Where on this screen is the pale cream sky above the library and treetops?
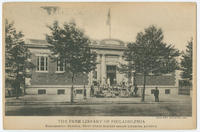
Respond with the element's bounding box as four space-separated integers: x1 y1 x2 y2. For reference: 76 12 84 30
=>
3 3 196 50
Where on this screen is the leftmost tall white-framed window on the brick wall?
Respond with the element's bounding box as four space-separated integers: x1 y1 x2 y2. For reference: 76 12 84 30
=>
37 56 48 71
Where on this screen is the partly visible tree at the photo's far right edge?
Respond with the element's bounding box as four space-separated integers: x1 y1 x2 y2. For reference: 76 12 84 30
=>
181 39 193 81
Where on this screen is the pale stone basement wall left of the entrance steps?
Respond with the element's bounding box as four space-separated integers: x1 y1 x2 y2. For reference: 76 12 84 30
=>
26 85 90 102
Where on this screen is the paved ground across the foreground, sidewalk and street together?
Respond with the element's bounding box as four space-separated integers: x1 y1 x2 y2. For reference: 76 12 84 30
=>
5 95 192 116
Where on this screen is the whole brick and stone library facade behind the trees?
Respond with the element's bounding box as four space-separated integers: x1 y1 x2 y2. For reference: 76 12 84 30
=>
23 39 179 101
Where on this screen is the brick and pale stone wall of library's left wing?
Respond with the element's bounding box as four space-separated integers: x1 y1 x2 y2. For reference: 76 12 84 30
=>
26 48 90 102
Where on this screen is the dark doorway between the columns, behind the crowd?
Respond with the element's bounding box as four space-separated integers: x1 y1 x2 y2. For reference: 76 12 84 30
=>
106 65 116 86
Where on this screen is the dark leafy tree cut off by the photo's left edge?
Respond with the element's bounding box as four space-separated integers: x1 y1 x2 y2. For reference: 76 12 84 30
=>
5 19 34 98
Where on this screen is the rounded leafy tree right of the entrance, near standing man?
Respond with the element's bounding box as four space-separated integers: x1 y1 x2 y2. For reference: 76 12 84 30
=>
122 26 179 101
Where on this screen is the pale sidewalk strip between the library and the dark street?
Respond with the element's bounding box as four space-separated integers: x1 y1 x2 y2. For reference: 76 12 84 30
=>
6 95 192 105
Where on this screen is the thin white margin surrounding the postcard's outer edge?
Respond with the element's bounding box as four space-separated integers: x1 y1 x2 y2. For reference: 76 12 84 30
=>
0 0 200 132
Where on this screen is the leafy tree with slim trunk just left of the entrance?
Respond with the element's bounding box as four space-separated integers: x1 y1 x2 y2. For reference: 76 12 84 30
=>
46 21 96 103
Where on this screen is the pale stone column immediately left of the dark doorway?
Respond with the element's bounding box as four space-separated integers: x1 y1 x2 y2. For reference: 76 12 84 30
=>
101 55 106 84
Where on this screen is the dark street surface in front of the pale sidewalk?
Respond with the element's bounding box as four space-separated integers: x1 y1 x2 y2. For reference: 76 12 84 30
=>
6 103 192 116
